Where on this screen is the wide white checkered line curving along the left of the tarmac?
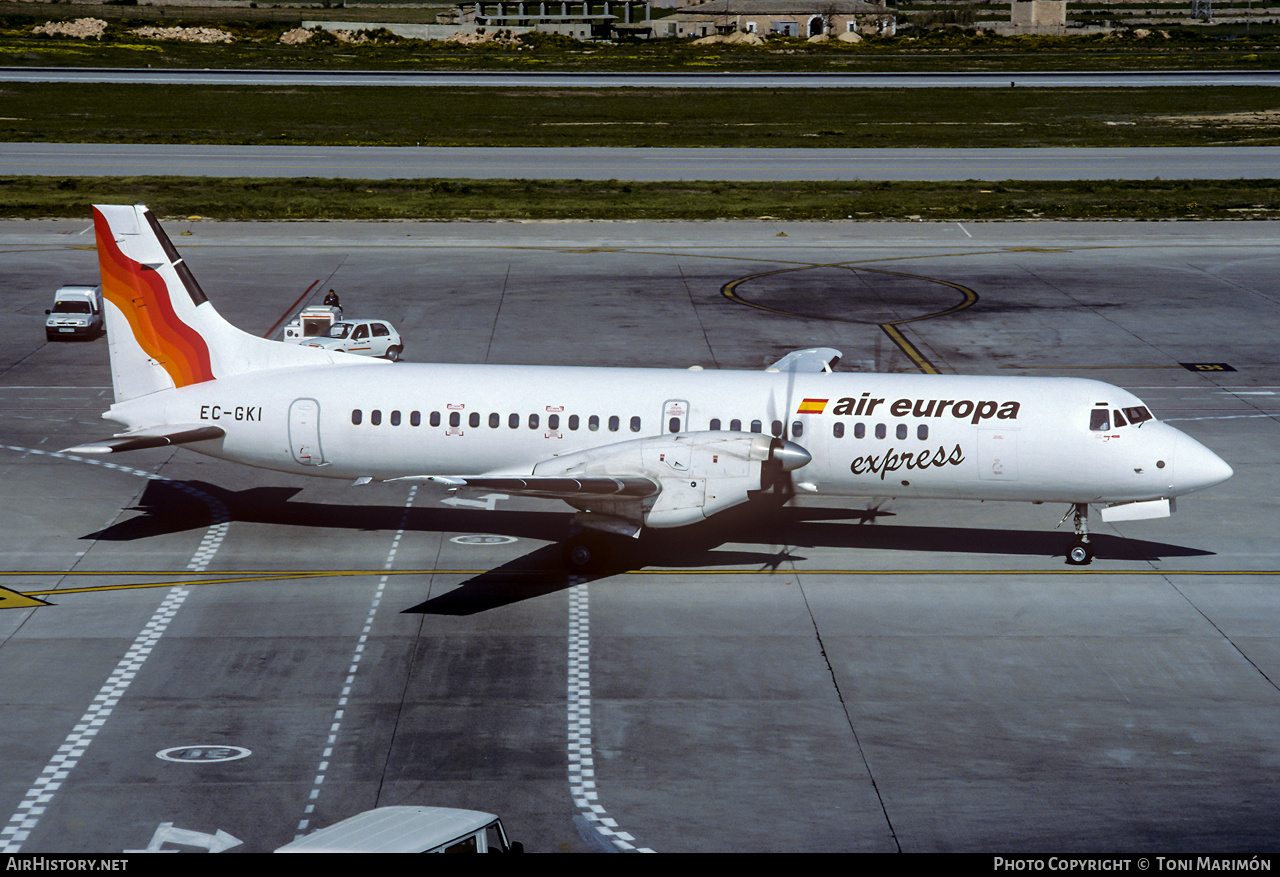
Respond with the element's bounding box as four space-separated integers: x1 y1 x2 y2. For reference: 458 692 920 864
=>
0 444 230 854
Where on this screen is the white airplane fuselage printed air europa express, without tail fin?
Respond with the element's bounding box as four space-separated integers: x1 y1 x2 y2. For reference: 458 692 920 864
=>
105 364 1230 503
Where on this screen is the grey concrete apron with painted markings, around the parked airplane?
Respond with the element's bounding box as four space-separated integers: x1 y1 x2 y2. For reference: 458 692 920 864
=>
0 218 1280 857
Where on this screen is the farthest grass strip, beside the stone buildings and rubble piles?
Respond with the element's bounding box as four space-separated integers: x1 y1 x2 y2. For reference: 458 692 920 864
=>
0 15 1280 72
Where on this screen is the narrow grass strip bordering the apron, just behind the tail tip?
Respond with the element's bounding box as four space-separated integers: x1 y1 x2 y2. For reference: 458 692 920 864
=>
0 177 1280 221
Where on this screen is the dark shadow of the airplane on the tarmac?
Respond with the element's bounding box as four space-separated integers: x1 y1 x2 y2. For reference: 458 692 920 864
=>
83 481 1212 615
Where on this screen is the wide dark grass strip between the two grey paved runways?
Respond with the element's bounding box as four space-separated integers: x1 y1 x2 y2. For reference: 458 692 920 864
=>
0 83 1280 147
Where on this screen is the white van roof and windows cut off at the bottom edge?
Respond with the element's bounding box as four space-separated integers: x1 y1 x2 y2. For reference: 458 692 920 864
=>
275 807 509 853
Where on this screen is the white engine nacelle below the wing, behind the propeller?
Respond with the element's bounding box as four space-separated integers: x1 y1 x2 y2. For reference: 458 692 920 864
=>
534 431 812 527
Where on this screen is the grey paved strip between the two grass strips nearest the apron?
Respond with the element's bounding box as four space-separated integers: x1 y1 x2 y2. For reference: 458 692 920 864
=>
0 143 1280 182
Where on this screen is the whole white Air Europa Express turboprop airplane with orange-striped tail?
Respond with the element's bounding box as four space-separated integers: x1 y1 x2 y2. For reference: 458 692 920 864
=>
69 205 1231 570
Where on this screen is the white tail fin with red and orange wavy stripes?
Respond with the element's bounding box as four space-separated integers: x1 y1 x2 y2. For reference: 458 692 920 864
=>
93 204 380 402
